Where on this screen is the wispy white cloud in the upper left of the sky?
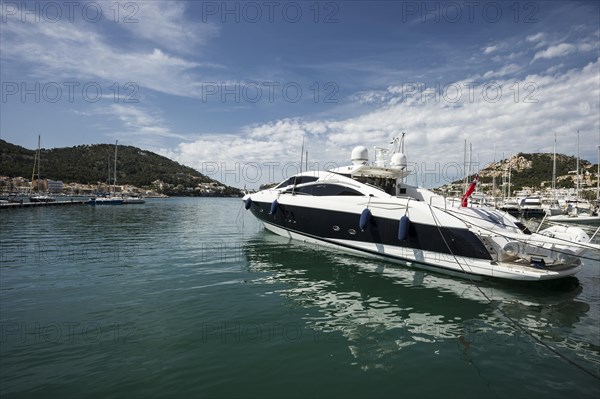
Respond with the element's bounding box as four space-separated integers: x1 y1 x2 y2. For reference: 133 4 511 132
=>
0 2 215 97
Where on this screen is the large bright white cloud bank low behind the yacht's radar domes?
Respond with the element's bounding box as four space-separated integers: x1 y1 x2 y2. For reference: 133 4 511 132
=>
163 61 600 187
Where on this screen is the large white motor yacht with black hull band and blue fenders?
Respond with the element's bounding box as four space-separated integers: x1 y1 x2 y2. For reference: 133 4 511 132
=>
243 137 600 281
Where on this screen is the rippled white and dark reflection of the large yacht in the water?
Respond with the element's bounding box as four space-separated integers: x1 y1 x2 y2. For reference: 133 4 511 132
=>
243 233 600 368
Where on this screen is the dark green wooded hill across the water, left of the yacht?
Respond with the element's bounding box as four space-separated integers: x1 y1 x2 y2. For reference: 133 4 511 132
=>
0 140 241 196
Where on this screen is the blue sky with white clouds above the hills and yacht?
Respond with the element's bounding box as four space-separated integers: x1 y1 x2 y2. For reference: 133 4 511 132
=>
0 1 600 187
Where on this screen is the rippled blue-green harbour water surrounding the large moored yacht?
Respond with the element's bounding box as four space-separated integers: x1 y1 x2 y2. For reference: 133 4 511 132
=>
0 198 600 399
